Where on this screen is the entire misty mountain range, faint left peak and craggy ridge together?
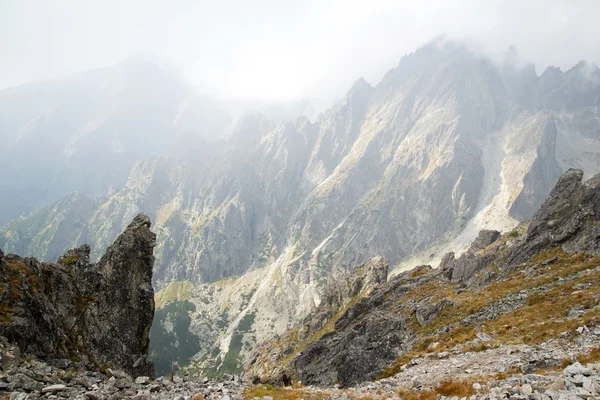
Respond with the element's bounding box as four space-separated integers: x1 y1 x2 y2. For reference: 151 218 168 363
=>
0 40 600 376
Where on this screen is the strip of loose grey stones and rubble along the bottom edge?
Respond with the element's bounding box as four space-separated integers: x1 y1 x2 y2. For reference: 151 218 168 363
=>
0 328 600 400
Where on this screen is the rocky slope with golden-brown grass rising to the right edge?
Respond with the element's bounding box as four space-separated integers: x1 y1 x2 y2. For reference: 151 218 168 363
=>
248 169 600 387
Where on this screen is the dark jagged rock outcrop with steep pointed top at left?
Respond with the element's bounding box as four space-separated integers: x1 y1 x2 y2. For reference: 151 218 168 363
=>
0 214 156 376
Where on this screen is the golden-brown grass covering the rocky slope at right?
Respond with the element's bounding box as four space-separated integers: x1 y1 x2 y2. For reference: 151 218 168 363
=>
379 248 600 379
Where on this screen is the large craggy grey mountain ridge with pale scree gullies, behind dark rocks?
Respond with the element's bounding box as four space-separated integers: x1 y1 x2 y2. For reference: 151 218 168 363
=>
0 41 600 373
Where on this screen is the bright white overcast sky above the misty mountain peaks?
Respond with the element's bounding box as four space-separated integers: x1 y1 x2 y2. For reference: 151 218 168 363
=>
0 0 600 100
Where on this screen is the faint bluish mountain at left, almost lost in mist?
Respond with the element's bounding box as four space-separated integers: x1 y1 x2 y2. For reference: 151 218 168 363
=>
0 57 231 224
